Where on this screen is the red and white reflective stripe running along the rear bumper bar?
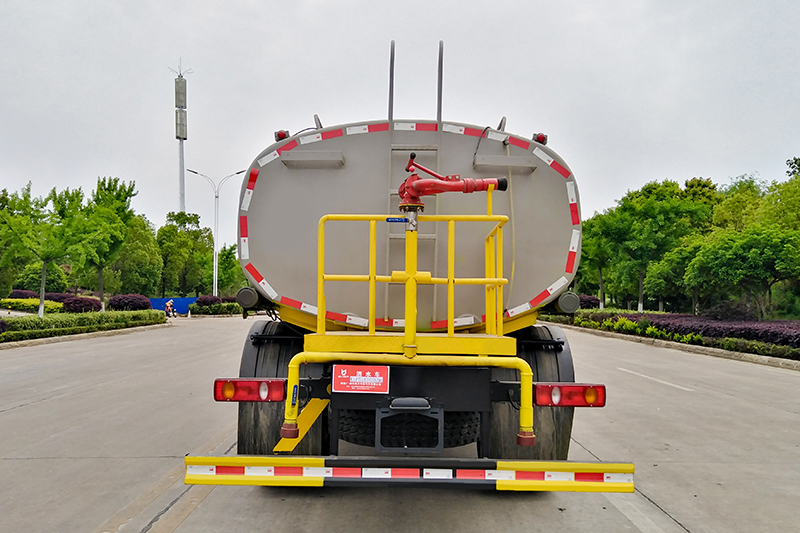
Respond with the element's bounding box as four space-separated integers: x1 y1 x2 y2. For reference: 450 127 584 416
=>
186 465 633 483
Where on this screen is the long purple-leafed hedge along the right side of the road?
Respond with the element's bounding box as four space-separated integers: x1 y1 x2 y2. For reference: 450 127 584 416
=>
620 314 800 348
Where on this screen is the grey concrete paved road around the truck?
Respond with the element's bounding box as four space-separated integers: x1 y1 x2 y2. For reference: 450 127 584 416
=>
0 318 800 533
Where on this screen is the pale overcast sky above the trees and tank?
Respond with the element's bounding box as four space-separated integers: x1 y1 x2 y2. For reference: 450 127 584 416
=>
0 0 800 247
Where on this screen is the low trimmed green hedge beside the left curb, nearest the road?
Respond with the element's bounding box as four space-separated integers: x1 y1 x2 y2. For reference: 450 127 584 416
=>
0 309 166 342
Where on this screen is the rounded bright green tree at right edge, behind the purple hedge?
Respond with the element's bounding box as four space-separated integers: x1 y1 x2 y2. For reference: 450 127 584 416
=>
684 226 800 319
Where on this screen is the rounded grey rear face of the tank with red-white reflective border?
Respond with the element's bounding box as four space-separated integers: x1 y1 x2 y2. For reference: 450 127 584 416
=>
239 119 581 331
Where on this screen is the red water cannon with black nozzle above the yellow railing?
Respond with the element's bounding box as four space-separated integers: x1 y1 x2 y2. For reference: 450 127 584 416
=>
398 152 508 211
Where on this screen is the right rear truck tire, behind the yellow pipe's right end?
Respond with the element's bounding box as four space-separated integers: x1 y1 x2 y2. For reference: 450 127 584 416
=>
488 325 575 461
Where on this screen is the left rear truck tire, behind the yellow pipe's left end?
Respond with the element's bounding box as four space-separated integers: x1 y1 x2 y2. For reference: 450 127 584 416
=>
237 320 327 455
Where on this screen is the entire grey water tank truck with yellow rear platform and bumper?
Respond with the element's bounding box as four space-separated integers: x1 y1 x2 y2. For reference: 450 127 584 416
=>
185 43 634 492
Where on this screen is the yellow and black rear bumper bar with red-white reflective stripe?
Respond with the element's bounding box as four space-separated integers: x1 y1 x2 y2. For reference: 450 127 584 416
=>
184 456 634 492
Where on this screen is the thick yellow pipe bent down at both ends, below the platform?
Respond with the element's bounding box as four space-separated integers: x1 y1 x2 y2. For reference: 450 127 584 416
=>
284 354 533 437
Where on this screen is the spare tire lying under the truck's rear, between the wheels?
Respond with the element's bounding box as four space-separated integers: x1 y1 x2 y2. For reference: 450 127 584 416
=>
339 409 481 448
